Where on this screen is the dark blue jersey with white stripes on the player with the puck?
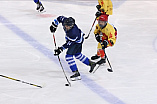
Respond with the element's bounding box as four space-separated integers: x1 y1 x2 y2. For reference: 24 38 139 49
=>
54 16 84 49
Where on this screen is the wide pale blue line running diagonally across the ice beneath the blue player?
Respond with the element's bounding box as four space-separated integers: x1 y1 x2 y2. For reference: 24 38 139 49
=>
0 15 125 104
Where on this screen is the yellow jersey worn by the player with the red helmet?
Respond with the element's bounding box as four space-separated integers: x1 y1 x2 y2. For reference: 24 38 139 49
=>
94 23 117 46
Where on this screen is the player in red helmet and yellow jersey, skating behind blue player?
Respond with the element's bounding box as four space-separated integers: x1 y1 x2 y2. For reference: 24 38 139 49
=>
91 15 117 65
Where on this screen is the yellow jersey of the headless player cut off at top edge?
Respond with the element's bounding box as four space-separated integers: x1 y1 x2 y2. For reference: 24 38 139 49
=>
98 0 113 15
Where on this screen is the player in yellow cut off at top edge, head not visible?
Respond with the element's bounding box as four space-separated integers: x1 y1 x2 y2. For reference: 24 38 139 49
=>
95 0 113 19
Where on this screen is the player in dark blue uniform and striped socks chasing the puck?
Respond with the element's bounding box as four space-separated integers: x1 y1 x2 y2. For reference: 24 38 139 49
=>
50 16 96 81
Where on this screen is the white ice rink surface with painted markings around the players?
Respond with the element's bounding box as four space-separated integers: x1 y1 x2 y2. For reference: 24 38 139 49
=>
0 0 157 104
